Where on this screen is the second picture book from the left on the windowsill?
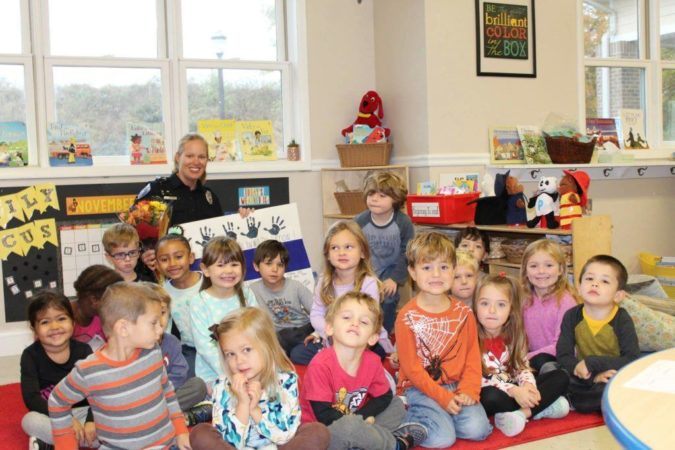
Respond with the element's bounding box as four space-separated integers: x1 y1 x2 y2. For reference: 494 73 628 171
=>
47 122 93 166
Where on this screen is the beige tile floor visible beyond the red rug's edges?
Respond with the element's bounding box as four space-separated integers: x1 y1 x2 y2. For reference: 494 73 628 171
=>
0 356 621 450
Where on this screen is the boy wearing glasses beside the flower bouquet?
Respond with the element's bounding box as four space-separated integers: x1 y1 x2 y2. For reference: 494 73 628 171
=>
102 223 155 282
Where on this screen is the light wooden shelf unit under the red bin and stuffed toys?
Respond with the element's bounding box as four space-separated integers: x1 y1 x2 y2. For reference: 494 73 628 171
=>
420 215 612 284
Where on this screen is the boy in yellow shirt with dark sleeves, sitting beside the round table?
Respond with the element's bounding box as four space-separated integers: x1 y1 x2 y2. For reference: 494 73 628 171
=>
557 255 640 412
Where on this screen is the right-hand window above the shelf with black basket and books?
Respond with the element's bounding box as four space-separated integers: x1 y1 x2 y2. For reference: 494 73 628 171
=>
582 0 675 148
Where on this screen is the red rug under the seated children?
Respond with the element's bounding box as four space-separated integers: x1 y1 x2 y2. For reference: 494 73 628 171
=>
0 383 604 450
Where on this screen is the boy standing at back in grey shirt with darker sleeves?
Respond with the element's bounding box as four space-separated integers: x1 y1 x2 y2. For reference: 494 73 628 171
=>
354 172 415 333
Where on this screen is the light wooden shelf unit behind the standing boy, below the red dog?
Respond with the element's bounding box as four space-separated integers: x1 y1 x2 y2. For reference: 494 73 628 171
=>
321 166 410 231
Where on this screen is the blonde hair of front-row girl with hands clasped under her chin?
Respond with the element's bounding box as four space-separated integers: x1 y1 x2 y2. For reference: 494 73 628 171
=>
213 306 295 397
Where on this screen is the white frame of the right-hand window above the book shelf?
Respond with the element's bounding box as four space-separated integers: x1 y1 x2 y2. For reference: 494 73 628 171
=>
577 0 675 153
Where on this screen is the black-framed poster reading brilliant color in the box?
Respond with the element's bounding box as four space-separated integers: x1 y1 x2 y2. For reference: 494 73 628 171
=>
476 0 537 78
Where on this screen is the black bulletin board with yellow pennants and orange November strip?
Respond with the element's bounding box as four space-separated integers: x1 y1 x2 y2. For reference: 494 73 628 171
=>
0 177 289 322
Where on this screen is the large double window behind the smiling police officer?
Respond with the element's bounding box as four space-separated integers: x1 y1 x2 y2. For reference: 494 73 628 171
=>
0 0 309 178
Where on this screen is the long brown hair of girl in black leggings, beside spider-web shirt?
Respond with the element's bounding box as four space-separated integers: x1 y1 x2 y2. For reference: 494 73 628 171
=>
473 274 530 376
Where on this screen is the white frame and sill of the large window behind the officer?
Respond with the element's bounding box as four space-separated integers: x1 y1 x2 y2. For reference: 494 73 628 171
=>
0 0 311 180
